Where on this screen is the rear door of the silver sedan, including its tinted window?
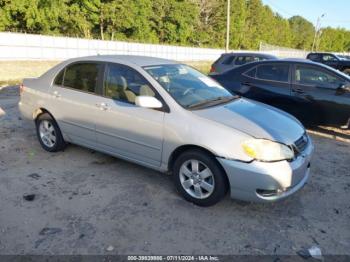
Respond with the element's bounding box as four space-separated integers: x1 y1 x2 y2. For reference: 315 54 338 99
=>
49 62 103 147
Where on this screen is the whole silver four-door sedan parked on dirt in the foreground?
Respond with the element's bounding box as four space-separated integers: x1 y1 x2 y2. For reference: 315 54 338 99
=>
19 55 313 206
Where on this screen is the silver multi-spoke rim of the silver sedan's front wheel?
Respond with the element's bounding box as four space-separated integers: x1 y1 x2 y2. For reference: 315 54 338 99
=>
179 159 215 199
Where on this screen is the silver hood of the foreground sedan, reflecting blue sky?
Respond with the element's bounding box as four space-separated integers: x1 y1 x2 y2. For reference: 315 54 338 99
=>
192 98 305 145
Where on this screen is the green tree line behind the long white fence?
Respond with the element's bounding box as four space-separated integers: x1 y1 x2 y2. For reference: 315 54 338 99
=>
0 0 350 52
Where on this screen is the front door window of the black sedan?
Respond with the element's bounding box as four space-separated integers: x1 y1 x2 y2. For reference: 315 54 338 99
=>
295 66 345 88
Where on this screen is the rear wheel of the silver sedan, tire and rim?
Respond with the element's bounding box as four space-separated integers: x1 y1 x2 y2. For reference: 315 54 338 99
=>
35 113 66 152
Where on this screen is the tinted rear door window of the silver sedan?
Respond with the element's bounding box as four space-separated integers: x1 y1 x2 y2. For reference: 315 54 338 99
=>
63 63 101 93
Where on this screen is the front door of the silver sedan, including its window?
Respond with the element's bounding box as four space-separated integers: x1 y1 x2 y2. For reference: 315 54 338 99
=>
96 63 165 167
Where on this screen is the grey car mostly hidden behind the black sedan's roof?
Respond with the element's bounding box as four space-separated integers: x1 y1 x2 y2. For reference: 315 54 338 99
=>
209 53 277 75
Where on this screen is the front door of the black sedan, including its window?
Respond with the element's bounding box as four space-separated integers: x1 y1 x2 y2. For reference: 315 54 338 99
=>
292 64 350 125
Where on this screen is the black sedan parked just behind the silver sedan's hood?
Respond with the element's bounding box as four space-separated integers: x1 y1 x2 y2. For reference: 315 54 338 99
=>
212 59 350 128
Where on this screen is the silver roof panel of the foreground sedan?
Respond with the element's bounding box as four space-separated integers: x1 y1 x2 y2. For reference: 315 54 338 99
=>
62 55 179 67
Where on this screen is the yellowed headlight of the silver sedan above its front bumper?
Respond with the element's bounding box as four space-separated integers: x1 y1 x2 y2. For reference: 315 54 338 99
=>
242 139 294 162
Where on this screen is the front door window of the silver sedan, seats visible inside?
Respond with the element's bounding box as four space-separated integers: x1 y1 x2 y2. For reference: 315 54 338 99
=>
104 64 156 104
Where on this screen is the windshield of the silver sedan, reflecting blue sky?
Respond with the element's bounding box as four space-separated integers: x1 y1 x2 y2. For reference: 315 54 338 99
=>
144 64 236 109
